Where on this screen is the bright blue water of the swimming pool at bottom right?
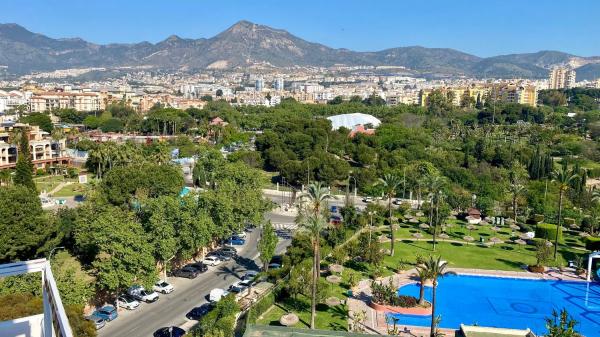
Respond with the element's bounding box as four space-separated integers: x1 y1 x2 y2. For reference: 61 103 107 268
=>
388 275 600 337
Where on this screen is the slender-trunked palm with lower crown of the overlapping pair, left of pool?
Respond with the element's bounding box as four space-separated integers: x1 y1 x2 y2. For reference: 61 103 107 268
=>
300 213 327 329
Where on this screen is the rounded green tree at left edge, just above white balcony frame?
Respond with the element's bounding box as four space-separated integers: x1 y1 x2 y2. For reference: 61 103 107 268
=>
0 185 49 262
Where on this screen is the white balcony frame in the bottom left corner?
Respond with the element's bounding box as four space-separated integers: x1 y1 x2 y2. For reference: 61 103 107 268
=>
0 259 73 337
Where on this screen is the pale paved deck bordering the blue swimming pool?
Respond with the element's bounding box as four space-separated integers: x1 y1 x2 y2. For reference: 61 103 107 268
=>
347 268 586 337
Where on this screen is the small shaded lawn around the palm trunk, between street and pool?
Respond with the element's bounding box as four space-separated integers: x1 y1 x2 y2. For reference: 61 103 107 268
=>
256 276 349 331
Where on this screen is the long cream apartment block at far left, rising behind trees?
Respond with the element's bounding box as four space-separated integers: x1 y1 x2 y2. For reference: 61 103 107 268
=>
29 91 104 112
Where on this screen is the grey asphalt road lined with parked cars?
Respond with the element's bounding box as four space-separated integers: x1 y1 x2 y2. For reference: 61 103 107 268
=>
98 214 294 337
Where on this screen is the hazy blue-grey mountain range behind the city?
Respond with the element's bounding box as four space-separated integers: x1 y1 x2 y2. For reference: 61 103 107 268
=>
0 21 600 80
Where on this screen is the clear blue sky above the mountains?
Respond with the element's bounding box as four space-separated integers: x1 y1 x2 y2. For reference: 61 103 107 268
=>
0 0 600 56
